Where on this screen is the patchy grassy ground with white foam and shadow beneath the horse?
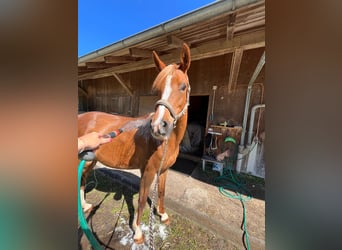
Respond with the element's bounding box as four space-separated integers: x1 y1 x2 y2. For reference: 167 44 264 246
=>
78 168 232 250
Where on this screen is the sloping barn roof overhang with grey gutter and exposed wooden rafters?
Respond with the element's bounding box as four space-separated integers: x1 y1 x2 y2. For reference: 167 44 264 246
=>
78 0 265 80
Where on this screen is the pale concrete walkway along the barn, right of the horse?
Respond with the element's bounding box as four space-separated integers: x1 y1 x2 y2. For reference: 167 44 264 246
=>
79 159 265 249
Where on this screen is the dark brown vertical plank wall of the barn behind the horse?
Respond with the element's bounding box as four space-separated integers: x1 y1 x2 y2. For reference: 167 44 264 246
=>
79 48 265 134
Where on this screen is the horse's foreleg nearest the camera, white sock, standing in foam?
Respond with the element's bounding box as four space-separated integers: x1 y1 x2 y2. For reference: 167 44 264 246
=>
133 171 155 244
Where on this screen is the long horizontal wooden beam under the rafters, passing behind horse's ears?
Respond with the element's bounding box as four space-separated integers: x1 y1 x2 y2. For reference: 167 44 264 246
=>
78 30 265 80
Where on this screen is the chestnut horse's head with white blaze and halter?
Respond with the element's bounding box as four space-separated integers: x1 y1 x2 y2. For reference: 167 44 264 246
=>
151 44 191 140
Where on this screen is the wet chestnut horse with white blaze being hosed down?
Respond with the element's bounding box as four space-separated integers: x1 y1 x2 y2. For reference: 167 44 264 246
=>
78 44 191 244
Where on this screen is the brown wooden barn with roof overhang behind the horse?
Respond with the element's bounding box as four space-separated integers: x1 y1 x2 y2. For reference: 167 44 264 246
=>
78 0 265 178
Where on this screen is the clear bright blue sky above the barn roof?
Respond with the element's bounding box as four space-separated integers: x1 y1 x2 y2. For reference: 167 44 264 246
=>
78 0 215 56
